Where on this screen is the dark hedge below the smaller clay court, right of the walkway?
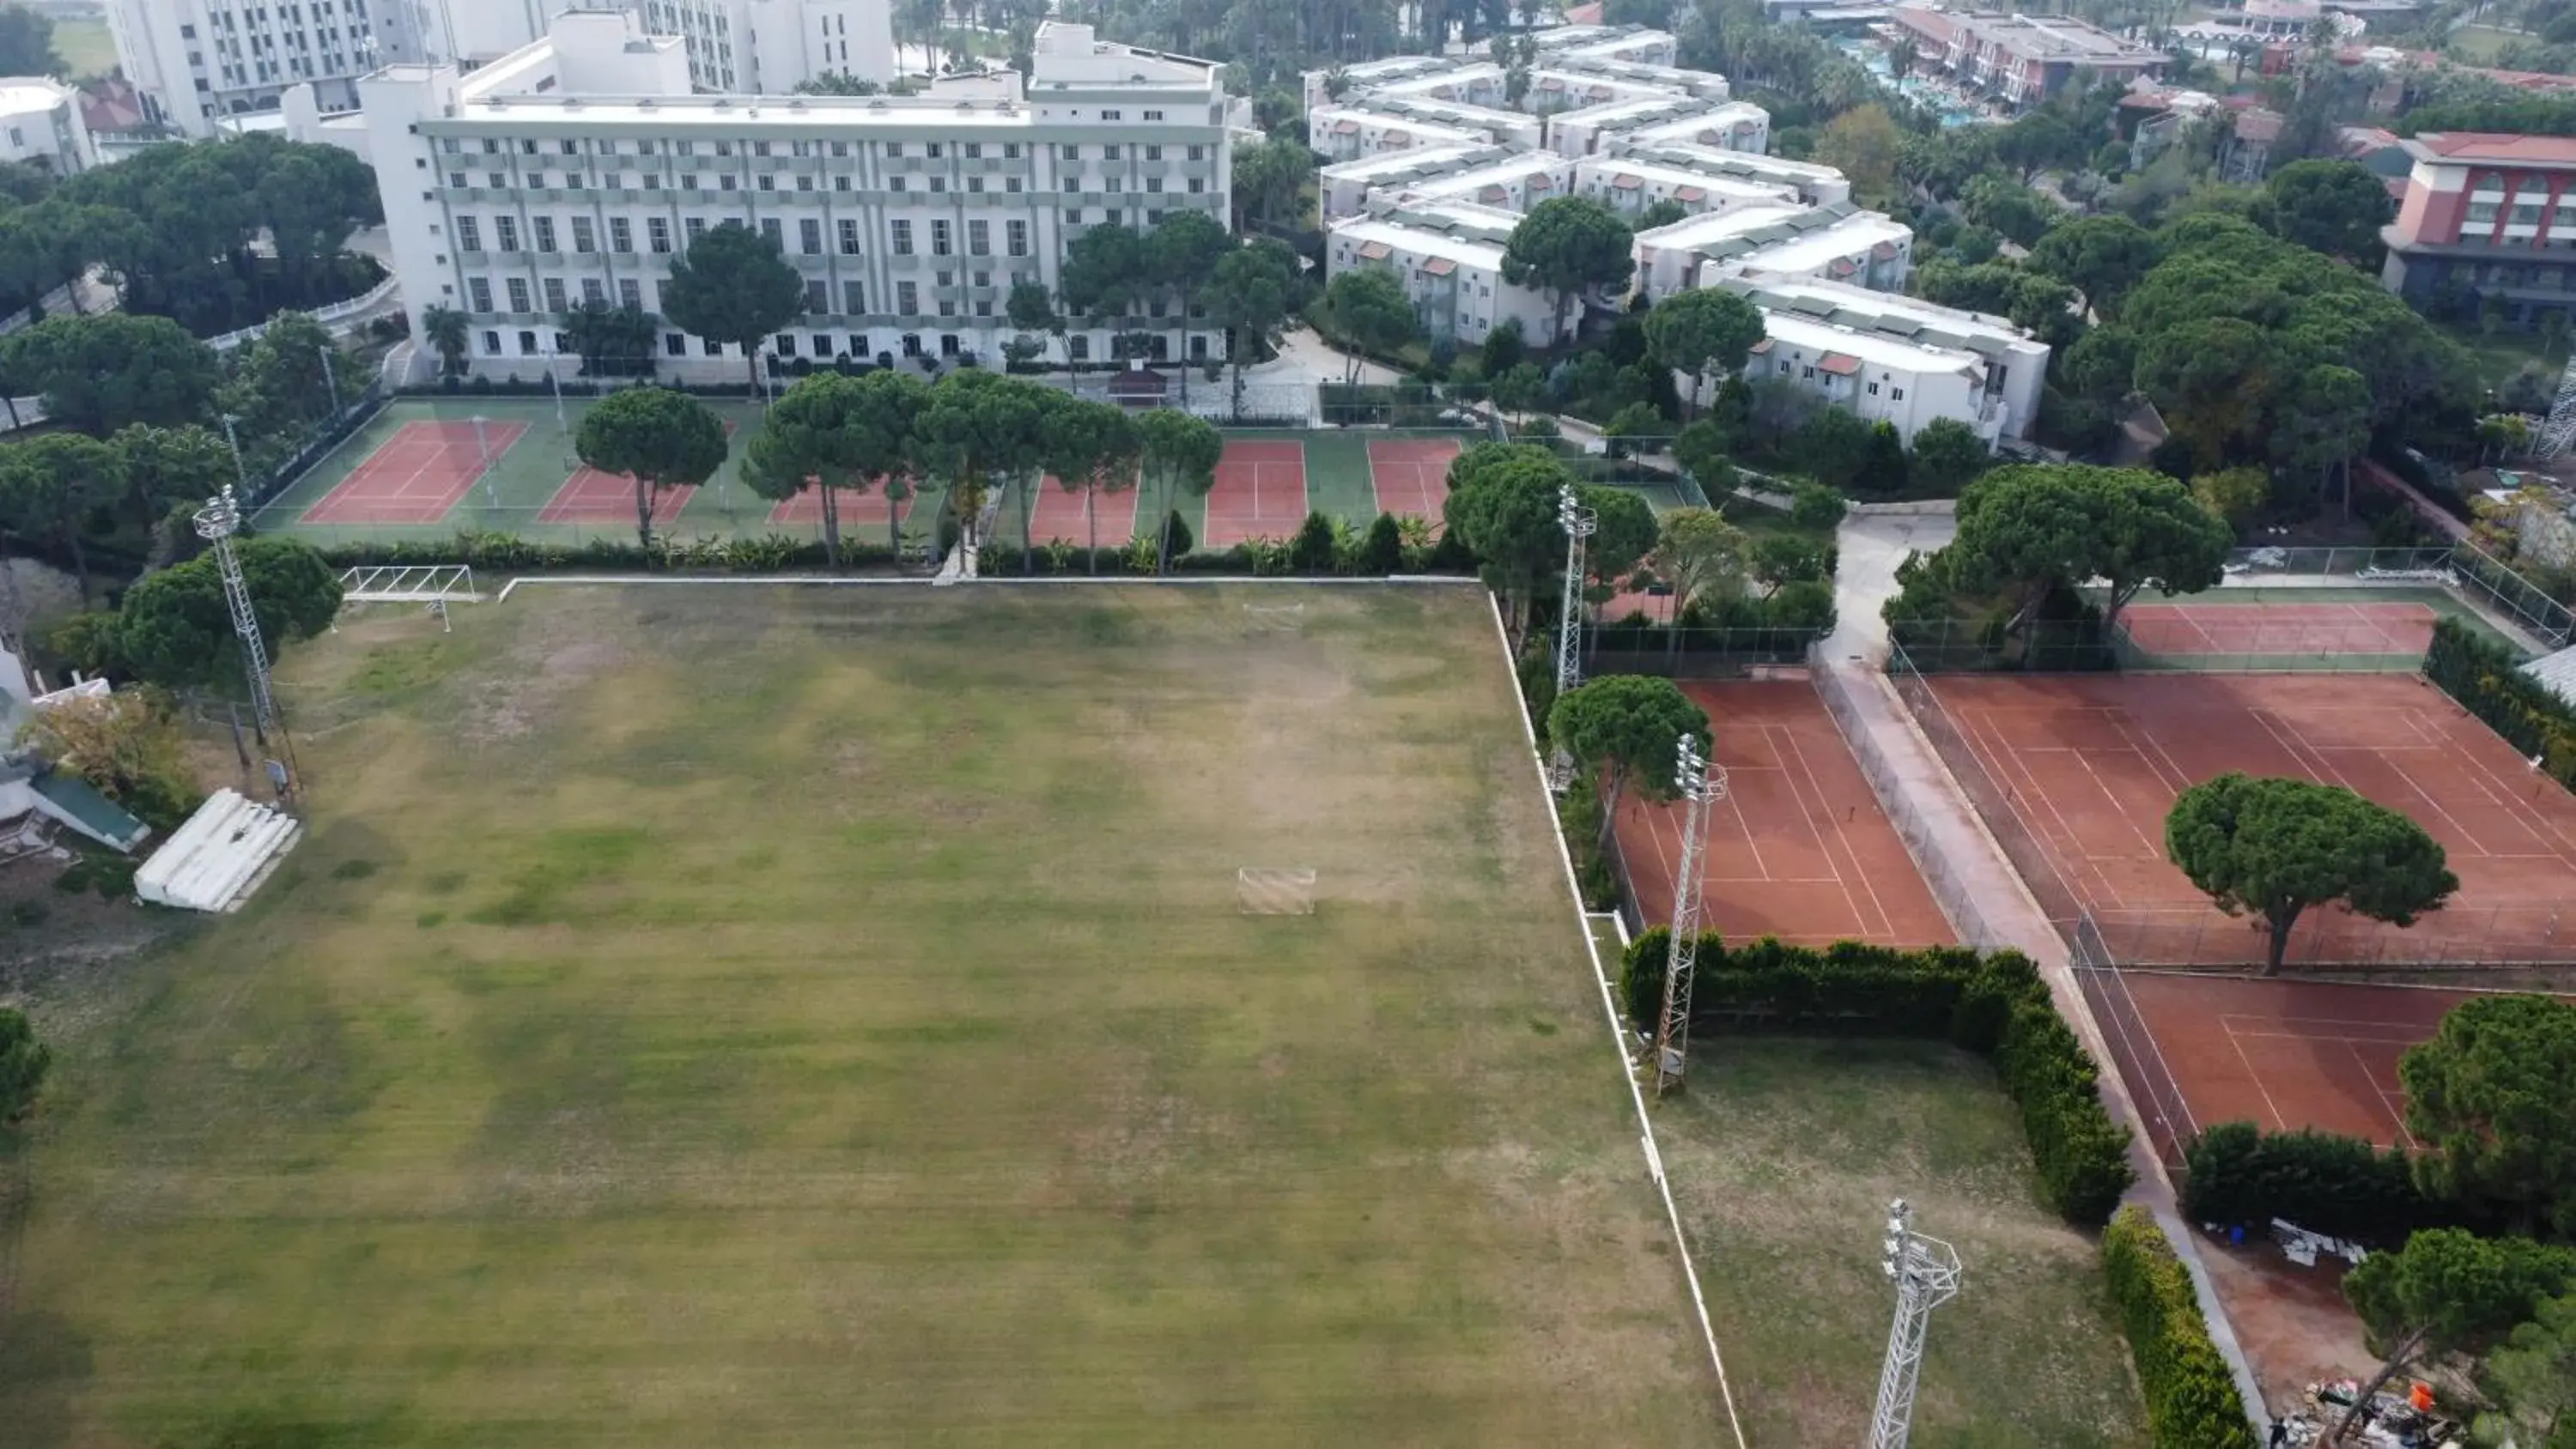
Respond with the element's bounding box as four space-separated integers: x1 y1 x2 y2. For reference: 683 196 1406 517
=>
2182 1122 2445 1248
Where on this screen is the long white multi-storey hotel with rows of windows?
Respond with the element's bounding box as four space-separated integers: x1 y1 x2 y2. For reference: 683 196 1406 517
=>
361 13 1231 381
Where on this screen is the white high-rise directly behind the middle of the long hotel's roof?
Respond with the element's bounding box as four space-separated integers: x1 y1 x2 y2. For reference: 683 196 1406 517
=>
623 0 894 95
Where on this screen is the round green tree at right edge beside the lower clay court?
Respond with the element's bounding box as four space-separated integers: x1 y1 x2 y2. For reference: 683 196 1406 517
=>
2398 996 2576 1238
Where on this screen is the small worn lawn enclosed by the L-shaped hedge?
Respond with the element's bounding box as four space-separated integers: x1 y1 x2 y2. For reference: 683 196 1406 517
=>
1656 1034 2146 1449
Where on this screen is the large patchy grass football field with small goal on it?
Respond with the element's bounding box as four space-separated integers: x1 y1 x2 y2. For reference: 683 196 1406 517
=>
15 587 1731 1449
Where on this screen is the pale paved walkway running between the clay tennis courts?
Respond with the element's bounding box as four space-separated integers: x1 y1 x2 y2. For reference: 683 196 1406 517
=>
1819 515 2269 1434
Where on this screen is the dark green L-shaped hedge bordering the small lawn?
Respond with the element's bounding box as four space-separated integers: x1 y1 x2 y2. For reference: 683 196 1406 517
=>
1620 926 2136 1228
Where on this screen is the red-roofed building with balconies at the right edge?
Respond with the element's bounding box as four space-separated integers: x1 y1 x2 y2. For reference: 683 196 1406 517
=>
2380 131 2576 327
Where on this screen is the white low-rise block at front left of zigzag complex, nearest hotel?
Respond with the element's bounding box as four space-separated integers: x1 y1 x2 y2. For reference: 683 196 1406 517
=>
1324 203 1582 348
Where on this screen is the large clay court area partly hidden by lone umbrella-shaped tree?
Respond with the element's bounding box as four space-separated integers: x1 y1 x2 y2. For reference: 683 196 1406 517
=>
1906 675 2576 967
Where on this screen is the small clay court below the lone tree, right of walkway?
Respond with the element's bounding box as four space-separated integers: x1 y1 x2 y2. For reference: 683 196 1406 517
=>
2076 970 2514 1161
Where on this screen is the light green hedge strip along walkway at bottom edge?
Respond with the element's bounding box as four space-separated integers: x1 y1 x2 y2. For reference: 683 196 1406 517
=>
2102 1207 2254 1449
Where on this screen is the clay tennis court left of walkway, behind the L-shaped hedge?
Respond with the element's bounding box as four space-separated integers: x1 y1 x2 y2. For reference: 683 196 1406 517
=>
1618 680 1955 944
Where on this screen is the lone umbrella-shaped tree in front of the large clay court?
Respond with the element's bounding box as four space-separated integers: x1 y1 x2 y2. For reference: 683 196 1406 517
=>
2164 772 2460 975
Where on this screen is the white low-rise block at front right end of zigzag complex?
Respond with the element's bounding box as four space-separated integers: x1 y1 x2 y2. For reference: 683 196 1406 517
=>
1721 273 2048 443
